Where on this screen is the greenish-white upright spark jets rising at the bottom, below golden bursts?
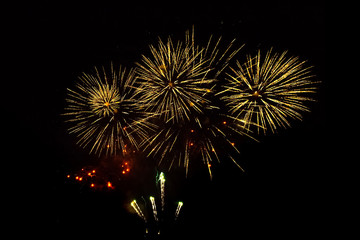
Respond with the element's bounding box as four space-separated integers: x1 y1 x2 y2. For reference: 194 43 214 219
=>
130 172 184 235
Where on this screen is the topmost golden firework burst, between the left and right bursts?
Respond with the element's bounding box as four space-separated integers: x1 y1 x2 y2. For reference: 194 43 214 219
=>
137 27 239 122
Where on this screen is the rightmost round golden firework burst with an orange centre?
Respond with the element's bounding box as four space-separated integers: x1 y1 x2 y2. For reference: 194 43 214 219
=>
219 50 316 133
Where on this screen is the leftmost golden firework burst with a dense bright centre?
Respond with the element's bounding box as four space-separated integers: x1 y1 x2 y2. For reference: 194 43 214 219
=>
64 64 151 155
